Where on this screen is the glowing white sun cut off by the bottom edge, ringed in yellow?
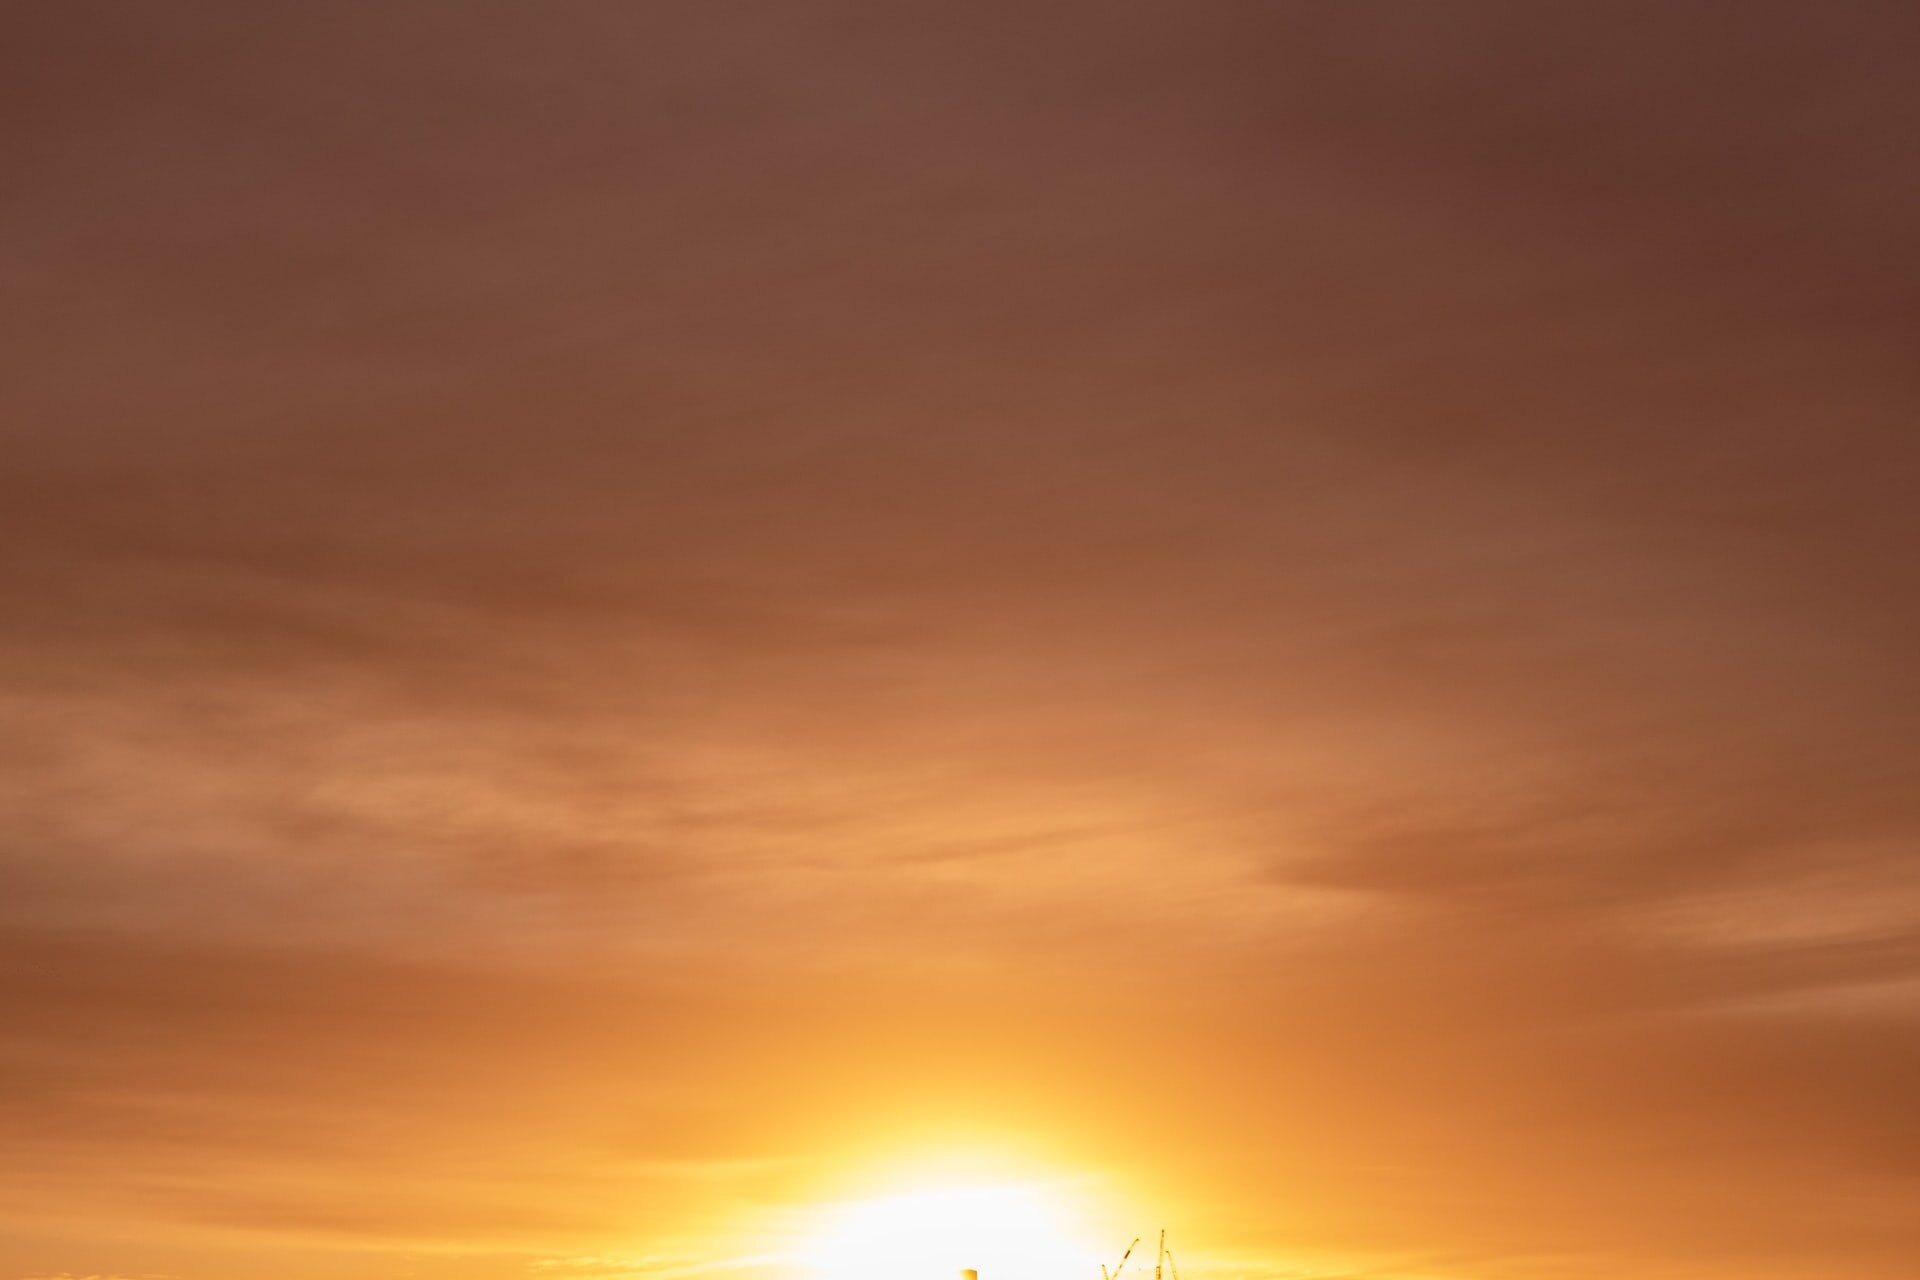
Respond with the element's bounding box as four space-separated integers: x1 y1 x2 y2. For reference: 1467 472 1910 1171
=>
804 1184 1100 1280
